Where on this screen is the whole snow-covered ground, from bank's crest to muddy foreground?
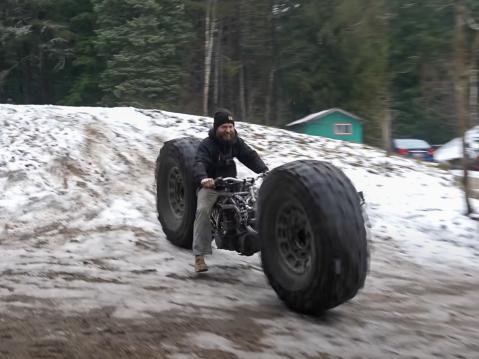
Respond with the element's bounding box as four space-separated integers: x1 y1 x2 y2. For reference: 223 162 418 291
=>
0 105 479 359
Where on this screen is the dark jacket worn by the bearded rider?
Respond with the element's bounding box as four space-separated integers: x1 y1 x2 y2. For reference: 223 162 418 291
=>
194 129 268 186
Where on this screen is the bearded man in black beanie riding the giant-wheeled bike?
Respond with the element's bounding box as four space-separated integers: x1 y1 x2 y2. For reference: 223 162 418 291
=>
193 109 268 272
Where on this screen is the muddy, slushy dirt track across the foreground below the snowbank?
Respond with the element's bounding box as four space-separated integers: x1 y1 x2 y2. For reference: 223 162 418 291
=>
0 228 479 359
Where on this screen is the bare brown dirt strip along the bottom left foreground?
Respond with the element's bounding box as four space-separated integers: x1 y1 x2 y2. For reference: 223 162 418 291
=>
0 304 278 359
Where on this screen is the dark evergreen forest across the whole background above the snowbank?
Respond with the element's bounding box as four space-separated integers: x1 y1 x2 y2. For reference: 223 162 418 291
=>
0 0 479 146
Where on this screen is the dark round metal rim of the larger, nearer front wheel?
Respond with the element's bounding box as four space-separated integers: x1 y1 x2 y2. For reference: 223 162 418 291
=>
275 203 313 276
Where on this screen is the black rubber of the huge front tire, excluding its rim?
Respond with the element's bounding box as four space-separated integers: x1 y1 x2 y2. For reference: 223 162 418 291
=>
258 160 368 314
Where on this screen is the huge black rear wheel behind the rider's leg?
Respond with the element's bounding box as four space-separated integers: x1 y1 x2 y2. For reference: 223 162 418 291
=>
155 137 200 249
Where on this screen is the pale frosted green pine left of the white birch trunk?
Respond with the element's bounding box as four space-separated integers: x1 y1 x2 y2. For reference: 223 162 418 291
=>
94 0 191 109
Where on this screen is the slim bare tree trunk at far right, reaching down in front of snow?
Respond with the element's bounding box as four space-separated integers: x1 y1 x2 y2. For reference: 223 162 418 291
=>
454 0 473 215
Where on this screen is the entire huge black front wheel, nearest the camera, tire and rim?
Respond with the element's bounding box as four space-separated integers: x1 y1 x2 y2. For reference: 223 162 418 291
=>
258 160 368 314
